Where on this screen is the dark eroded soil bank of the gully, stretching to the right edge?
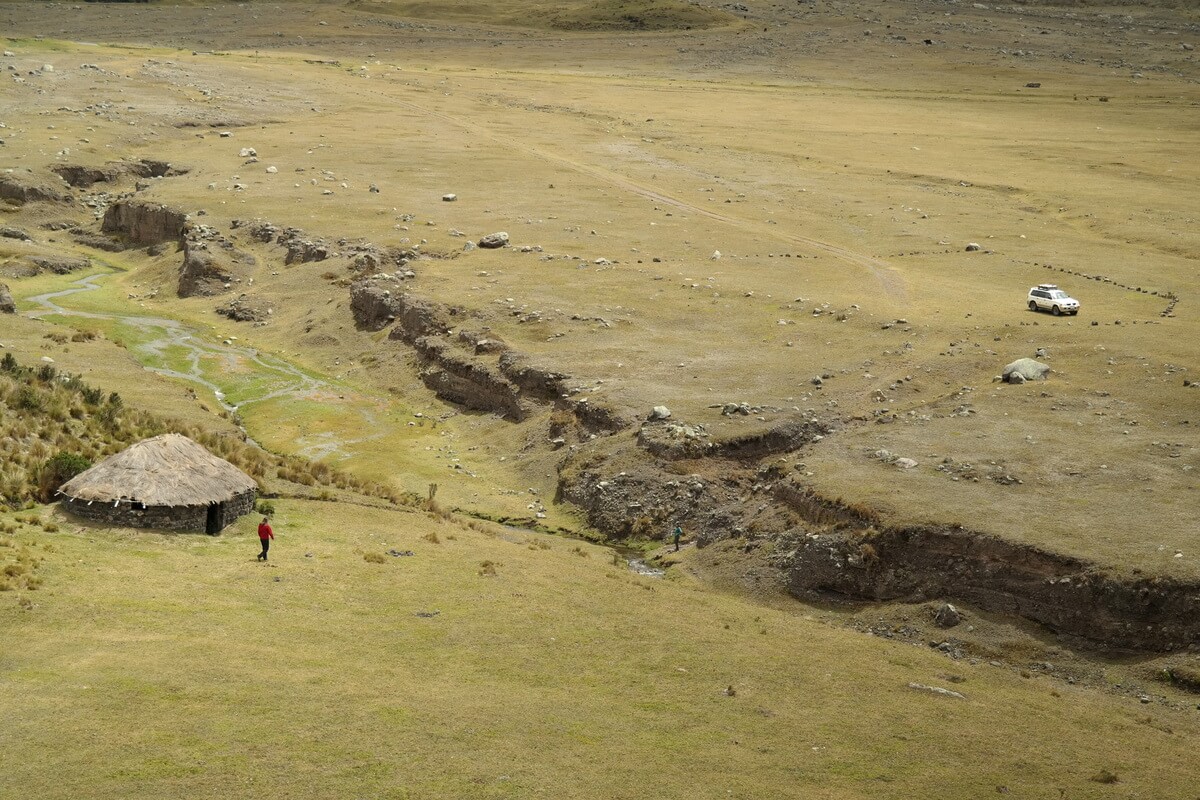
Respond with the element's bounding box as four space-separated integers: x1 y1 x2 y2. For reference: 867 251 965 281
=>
559 435 1200 651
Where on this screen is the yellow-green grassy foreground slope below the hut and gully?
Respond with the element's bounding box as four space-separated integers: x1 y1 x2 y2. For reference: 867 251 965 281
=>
7 501 1200 799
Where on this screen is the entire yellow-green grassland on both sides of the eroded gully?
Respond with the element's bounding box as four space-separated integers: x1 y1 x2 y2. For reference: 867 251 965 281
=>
0 2 1200 799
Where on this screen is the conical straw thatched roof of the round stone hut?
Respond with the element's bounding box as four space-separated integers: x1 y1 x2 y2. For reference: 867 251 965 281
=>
59 433 258 506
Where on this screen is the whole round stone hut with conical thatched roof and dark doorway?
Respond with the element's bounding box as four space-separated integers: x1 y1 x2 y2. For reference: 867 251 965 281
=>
59 433 258 534
